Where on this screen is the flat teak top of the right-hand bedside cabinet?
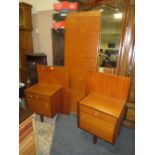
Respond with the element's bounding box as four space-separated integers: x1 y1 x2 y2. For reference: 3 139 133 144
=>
80 93 125 117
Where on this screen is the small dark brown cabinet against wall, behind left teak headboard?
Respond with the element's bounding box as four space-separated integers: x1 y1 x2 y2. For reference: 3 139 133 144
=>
25 53 47 86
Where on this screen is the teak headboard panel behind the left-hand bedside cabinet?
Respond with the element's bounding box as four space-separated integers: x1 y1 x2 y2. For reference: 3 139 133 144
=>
37 65 70 114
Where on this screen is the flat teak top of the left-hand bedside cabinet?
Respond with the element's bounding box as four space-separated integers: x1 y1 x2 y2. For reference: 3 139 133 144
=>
25 83 62 96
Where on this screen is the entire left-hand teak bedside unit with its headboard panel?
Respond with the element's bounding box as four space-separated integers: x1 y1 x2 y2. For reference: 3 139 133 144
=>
25 65 69 120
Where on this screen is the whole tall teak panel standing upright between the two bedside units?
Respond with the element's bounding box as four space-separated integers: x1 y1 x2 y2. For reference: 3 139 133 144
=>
65 11 101 112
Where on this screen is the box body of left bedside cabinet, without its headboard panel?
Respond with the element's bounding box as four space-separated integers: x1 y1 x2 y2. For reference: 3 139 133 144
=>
25 83 62 120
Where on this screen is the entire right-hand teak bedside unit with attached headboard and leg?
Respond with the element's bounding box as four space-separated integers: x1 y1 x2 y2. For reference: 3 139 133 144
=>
78 72 130 144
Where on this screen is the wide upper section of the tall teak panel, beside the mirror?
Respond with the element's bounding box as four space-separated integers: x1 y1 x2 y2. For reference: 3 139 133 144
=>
65 11 100 70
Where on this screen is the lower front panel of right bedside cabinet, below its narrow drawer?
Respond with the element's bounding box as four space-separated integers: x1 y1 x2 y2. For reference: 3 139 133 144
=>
79 112 115 142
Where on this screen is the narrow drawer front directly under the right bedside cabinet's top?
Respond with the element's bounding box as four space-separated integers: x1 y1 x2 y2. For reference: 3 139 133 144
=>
80 105 117 124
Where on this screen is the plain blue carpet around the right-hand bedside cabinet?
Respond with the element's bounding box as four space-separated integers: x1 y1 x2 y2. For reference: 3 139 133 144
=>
50 115 135 155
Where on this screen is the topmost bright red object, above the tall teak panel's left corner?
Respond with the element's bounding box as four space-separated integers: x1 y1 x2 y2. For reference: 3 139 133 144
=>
53 1 78 11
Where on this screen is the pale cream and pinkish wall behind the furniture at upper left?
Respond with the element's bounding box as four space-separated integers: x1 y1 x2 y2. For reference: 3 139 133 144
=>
19 0 58 65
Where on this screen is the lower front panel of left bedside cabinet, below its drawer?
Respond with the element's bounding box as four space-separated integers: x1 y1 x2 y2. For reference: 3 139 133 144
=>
26 98 52 116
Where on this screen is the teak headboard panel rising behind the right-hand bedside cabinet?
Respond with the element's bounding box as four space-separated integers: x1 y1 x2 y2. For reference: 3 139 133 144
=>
86 72 130 101
